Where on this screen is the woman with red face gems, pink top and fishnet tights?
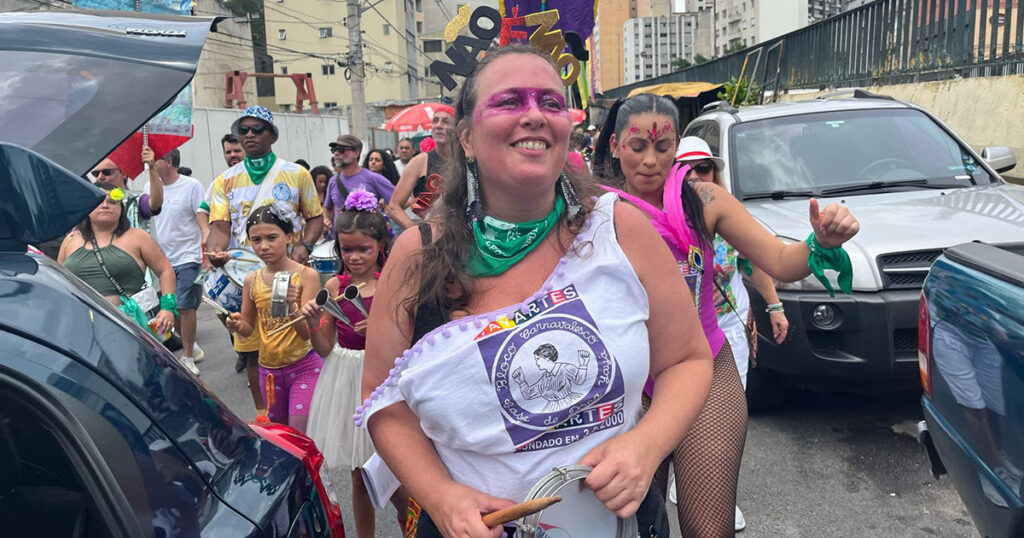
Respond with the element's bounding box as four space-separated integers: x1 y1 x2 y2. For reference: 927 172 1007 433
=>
594 94 860 537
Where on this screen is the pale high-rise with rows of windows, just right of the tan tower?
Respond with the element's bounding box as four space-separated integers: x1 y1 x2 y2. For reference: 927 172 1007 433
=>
623 13 696 84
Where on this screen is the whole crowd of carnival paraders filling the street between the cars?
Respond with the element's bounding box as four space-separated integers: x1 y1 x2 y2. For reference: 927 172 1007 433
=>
51 46 859 537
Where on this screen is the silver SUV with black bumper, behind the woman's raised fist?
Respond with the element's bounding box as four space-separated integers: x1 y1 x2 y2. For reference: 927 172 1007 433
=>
684 90 1024 410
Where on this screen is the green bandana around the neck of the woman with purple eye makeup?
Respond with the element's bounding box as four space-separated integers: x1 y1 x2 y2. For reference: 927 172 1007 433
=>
466 194 565 277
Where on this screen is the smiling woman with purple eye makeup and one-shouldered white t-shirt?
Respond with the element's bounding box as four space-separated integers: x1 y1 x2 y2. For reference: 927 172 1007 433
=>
356 46 711 537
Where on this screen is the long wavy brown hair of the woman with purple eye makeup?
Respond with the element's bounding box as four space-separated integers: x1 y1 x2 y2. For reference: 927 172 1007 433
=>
403 45 598 317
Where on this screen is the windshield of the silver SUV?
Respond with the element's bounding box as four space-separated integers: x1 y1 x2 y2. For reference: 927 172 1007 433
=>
730 109 992 198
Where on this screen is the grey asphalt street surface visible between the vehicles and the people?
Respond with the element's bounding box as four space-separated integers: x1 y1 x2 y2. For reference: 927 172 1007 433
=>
190 307 978 538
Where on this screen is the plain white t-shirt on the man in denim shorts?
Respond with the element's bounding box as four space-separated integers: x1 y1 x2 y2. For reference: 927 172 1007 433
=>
153 175 204 265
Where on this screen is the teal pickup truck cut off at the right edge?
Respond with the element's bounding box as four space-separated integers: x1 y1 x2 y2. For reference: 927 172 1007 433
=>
918 240 1024 537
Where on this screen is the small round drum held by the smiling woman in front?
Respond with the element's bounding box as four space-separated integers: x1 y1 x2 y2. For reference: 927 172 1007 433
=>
516 465 639 538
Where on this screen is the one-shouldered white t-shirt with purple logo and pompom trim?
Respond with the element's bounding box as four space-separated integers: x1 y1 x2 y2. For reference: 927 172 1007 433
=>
356 194 650 501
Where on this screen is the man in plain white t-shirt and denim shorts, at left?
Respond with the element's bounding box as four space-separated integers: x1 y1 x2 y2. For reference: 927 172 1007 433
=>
153 150 204 375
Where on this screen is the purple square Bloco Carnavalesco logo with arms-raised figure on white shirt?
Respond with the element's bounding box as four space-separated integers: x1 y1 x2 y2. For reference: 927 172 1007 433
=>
476 285 625 452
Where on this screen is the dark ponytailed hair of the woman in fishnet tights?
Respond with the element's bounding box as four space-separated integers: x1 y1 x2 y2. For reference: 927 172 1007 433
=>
593 93 714 243
